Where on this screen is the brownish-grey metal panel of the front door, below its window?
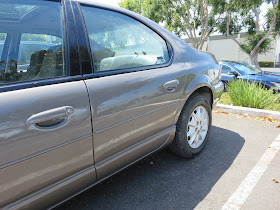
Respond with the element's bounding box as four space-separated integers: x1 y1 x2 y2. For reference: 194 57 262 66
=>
0 81 93 206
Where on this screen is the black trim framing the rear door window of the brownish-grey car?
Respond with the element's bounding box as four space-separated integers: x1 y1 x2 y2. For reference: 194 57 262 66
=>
75 2 174 79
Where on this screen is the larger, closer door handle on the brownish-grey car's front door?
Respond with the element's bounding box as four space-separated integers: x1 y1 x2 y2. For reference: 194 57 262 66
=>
26 106 74 128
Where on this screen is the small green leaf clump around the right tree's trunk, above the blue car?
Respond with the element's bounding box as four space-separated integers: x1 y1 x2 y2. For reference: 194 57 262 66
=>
241 33 272 54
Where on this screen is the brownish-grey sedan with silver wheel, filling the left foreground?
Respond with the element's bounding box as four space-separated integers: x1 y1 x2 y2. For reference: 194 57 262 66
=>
0 0 223 209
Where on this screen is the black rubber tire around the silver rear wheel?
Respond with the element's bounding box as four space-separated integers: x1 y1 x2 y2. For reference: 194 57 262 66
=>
170 94 212 158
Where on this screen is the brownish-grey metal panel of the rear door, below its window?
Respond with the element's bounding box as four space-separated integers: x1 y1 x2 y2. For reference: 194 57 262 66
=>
85 60 186 178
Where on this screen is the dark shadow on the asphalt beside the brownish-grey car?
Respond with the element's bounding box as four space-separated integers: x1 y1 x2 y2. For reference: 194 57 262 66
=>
56 126 244 209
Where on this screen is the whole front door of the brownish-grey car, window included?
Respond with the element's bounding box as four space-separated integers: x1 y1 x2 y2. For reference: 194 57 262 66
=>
0 0 96 208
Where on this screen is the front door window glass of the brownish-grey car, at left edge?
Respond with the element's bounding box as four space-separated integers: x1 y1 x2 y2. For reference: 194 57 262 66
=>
0 0 66 85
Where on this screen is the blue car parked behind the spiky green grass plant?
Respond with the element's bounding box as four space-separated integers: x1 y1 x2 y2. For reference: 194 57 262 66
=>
219 61 280 92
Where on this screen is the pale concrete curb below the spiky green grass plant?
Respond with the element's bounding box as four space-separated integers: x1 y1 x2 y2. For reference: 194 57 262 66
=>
214 104 280 121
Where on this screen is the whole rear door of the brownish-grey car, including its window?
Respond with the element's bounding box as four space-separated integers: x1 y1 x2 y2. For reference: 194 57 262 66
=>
77 3 186 179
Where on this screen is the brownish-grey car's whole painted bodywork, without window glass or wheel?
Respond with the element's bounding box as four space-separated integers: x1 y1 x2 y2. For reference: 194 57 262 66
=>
0 0 223 209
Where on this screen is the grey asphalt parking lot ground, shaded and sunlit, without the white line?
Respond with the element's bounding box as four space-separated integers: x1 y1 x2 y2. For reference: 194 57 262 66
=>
56 112 280 209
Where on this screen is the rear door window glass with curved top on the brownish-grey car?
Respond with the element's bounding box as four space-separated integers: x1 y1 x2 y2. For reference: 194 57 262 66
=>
82 6 169 72
